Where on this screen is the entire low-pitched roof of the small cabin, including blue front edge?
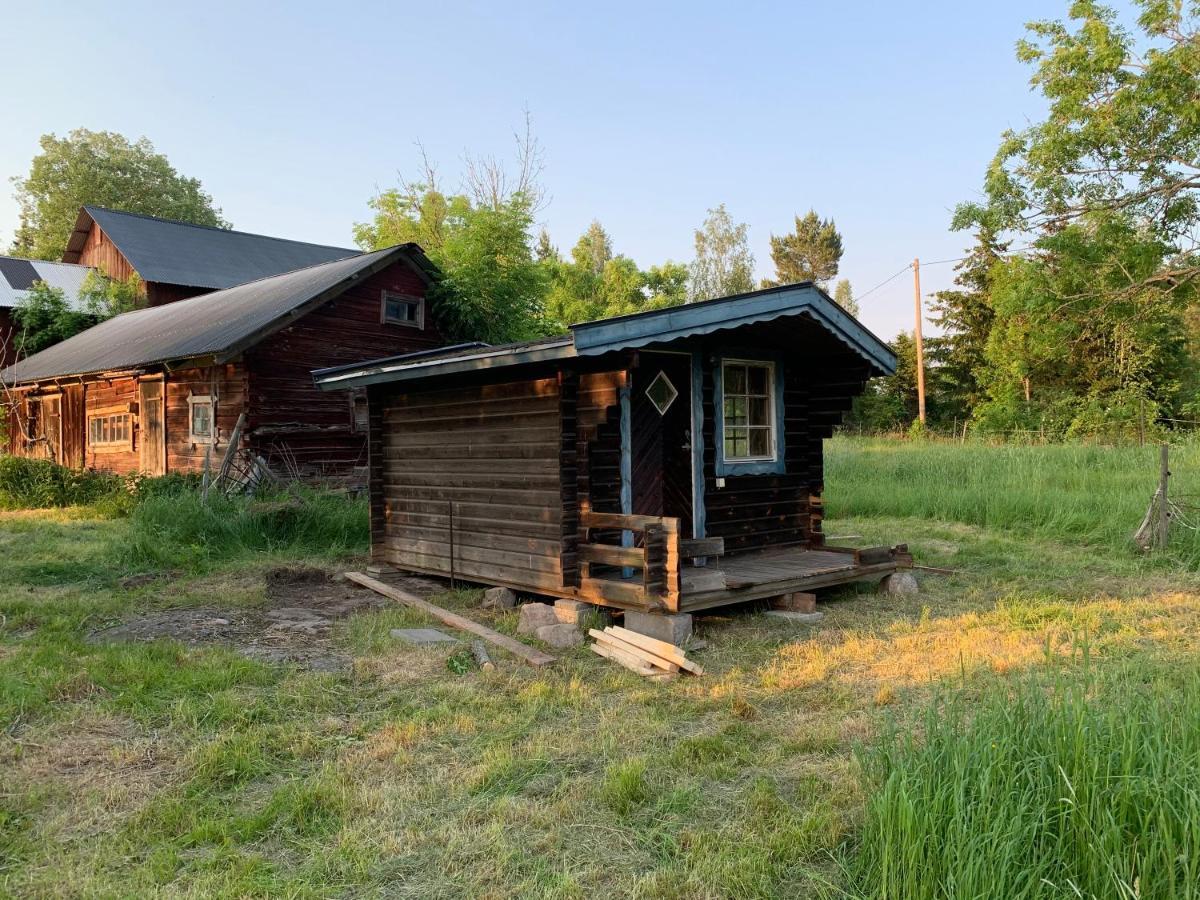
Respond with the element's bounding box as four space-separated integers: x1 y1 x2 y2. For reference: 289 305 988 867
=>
312 282 896 390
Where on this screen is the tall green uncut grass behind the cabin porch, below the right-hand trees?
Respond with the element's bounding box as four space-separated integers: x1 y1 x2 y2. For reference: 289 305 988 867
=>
826 437 1200 566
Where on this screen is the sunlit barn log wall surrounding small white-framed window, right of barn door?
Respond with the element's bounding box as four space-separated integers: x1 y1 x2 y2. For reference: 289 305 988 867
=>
164 362 247 473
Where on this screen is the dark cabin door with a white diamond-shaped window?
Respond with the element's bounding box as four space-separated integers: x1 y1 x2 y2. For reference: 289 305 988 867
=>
630 352 692 536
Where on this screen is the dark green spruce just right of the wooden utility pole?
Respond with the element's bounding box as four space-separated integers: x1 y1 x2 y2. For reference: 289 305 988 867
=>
925 228 1008 420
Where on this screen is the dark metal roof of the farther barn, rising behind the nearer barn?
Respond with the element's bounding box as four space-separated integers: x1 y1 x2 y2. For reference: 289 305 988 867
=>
62 206 359 289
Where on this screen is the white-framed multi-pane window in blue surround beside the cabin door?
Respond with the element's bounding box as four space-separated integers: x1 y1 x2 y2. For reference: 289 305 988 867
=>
721 359 779 462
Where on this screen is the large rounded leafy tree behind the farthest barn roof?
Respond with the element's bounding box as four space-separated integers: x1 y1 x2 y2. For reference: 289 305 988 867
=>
12 128 229 259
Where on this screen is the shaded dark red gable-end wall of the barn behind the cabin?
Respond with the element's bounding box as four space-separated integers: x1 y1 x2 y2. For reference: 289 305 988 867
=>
245 263 445 475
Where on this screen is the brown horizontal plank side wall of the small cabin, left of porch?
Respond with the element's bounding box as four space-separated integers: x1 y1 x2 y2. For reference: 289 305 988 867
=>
373 377 563 590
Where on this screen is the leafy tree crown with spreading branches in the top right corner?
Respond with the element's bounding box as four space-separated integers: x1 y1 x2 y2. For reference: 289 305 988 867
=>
955 0 1200 301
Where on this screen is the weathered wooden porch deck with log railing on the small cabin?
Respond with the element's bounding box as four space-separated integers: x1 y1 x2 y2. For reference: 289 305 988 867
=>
577 512 912 612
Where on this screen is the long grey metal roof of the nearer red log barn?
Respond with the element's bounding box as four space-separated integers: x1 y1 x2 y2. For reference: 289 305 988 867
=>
0 244 433 384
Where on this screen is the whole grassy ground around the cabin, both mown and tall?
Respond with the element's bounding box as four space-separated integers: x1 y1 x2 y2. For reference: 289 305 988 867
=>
0 439 1200 898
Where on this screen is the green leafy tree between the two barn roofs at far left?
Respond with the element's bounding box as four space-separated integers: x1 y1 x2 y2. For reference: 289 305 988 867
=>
13 271 140 356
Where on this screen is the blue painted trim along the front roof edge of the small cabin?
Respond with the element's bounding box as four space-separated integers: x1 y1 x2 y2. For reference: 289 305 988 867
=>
571 284 896 374
